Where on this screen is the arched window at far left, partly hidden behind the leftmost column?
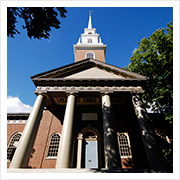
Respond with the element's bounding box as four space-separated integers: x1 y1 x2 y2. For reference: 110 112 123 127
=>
7 132 21 162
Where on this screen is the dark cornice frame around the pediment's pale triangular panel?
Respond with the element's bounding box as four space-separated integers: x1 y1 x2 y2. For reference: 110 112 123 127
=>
31 59 147 85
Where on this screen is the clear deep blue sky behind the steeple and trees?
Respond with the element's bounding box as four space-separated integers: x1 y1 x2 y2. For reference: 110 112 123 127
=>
7 6 173 112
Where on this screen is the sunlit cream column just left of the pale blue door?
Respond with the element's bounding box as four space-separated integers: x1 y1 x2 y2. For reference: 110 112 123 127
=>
56 93 76 168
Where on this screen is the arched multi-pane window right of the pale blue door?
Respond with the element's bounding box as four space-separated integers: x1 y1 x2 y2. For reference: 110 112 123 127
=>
118 133 132 158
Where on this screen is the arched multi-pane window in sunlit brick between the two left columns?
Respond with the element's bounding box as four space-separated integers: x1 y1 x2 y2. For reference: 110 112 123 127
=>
47 133 60 157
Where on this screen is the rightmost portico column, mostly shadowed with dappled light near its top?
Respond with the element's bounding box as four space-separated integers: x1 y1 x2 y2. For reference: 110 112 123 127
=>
132 95 164 169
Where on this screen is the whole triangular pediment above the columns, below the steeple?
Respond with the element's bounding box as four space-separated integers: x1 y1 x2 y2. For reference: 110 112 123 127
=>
31 59 147 86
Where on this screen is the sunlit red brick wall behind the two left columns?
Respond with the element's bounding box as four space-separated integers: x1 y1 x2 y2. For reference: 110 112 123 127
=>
7 110 62 168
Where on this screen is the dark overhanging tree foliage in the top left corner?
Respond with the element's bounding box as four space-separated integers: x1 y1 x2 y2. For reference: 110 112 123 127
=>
7 7 67 39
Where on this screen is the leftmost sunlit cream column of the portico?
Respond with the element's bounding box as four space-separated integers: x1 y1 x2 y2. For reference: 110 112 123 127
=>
9 94 46 168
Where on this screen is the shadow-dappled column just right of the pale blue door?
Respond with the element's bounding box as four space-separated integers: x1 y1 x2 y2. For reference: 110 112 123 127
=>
102 94 121 169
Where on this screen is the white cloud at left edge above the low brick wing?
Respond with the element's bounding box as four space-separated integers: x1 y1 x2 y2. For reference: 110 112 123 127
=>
7 96 32 113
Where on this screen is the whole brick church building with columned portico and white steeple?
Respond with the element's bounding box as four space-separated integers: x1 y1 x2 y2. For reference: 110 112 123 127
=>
7 15 163 169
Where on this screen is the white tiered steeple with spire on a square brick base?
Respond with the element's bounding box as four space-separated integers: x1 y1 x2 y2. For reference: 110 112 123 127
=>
74 11 107 62
